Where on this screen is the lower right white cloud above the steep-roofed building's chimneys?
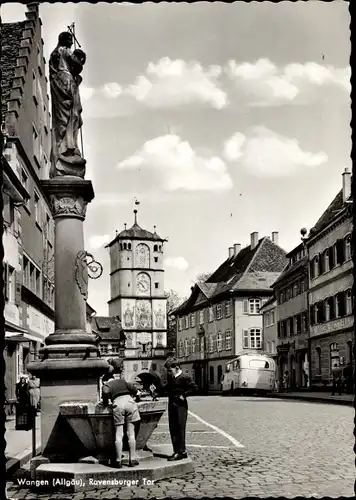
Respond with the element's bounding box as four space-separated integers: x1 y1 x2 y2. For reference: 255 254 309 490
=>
225 127 328 178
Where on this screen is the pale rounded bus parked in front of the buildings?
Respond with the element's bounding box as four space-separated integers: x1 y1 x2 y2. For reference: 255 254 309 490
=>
221 352 276 394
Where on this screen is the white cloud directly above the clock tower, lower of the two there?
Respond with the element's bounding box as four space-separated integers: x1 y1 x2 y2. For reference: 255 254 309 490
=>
118 134 232 192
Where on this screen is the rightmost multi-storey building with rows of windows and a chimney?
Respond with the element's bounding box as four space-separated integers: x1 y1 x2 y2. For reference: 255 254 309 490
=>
307 169 355 386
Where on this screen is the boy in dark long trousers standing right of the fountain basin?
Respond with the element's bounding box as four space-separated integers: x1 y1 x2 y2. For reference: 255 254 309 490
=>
158 358 198 461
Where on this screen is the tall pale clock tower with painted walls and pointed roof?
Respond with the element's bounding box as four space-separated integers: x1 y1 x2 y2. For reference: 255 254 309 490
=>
107 210 167 380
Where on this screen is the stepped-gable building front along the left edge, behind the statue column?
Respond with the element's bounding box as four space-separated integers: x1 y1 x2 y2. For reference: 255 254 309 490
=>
1 3 54 399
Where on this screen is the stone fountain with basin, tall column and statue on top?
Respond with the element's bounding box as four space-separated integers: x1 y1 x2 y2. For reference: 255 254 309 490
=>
28 25 193 492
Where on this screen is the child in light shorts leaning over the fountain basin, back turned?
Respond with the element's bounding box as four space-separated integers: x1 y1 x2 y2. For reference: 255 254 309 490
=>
101 359 141 469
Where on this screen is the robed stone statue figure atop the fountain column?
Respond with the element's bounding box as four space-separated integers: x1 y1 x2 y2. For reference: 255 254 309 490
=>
49 31 86 178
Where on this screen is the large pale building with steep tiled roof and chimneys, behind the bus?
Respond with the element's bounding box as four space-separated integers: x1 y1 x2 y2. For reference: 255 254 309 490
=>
175 232 286 392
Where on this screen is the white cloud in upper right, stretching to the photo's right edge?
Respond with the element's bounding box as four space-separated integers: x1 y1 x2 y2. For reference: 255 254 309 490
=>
224 59 351 106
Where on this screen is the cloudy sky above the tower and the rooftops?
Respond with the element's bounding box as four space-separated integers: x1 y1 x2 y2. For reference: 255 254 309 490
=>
1 0 352 315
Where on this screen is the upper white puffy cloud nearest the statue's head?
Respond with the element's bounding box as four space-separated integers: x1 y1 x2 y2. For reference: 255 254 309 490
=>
125 57 227 109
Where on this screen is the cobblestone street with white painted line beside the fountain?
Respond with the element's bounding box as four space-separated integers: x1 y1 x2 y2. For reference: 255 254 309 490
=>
8 396 355 500
